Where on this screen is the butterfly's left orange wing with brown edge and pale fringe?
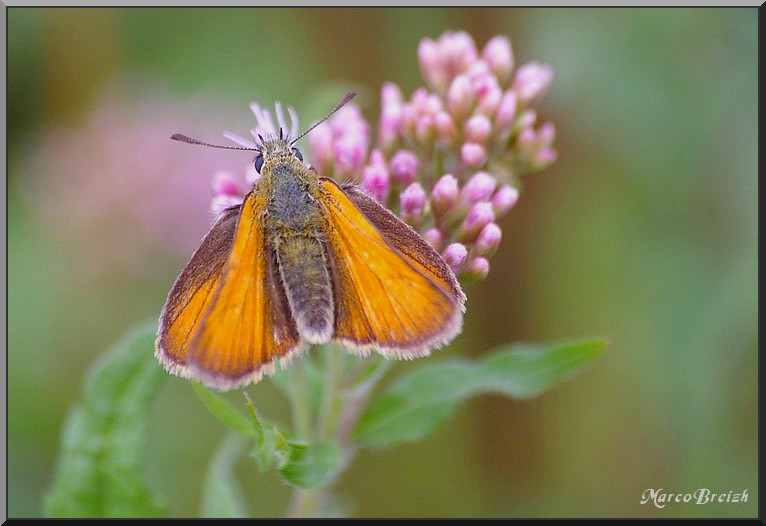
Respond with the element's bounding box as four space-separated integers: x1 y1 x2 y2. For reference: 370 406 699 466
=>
156 192 301 390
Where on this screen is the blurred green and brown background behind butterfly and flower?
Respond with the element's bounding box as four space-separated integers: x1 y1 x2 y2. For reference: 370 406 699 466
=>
8 8 758 517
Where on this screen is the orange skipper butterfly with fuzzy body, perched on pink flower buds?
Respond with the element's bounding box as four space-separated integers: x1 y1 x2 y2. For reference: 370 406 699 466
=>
155 93 465 390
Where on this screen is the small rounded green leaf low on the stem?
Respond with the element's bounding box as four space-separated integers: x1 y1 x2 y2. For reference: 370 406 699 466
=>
279 442 341 489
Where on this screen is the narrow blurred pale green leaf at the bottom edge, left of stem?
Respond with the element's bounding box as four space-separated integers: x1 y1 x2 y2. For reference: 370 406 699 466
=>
201 432 249 519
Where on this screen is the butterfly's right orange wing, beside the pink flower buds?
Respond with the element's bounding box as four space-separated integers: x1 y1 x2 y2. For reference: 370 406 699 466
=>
320 178 465 358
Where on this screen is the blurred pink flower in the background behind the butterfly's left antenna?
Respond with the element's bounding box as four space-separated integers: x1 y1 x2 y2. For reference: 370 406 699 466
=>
15 82 247 279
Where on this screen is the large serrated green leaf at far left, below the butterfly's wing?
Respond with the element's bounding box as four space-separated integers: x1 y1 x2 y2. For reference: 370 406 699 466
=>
44 323 167 517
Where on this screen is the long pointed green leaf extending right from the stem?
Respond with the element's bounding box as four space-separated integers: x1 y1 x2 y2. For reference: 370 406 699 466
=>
354 340 606 447
